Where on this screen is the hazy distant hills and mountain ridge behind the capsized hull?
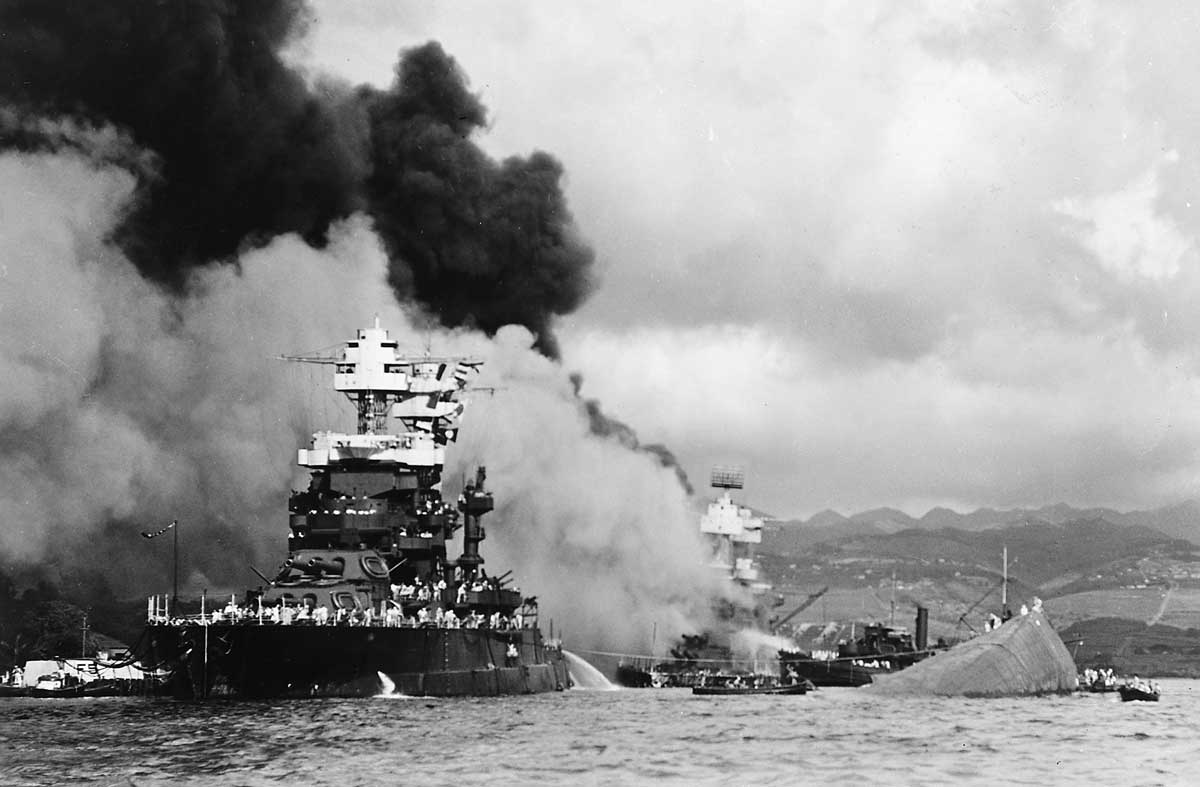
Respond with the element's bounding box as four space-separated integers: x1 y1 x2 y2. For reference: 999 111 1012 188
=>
757 500 1200 657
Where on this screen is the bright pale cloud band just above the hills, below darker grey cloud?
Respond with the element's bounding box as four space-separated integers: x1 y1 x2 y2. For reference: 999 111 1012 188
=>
564 322 1200 516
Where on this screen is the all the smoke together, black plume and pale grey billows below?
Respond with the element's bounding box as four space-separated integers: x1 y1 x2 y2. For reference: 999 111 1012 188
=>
0 0 722 648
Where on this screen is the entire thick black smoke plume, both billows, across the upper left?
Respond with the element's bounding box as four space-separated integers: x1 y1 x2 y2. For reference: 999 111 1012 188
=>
0 0 592 355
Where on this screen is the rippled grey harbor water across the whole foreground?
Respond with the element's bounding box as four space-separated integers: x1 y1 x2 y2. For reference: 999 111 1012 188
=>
0 680 1200 787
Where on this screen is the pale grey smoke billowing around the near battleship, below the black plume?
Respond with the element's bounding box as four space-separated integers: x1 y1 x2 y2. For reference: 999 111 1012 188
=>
0 141 714 648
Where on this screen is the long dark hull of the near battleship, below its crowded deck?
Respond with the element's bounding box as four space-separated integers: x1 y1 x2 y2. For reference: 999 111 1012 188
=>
145 624 570 699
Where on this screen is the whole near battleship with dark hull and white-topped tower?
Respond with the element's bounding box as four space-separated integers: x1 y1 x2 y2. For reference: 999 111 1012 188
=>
142 318 570 699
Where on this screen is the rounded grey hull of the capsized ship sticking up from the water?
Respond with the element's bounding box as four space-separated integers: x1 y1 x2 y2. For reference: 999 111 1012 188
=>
871 612 1079 697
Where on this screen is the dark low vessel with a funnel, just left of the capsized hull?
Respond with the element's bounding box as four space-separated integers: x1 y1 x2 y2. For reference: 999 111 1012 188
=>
779 607 935 686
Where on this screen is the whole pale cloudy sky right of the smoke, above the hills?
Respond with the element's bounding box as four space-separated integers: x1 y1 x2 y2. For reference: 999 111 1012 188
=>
289 0 1200 517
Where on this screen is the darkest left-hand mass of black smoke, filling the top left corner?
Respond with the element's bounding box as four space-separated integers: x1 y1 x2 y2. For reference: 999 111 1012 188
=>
0 0 361 286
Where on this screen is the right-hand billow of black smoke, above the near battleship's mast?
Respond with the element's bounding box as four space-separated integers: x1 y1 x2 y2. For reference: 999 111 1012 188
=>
361 43 592 355
